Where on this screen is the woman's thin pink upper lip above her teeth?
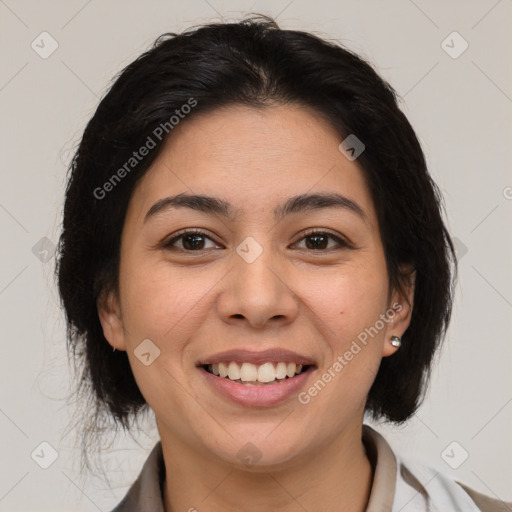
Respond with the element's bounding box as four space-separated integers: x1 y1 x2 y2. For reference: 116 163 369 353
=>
197 348 315 366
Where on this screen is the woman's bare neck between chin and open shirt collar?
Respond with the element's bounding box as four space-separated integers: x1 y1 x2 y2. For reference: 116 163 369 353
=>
161 424 373 512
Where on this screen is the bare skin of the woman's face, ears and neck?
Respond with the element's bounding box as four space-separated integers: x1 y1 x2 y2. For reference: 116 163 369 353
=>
98 105 413 512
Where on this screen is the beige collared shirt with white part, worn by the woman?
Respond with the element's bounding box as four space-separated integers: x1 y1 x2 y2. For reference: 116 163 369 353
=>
112 425 512 512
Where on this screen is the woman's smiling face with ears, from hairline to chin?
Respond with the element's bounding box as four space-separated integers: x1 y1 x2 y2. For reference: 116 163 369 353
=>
100 106 412 468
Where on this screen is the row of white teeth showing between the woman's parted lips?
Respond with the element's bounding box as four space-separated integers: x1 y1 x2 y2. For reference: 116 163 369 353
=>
201 361 313 386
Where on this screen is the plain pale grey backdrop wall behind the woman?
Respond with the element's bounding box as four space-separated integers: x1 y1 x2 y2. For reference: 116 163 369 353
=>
0 0 512 512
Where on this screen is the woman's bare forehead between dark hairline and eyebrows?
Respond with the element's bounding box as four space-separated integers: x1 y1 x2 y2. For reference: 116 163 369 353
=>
127 105 373 224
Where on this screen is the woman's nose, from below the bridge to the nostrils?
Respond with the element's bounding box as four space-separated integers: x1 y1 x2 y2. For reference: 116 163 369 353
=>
217 244 299 329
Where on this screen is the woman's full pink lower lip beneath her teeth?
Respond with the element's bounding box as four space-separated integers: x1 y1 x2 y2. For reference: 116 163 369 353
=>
199 367 314 407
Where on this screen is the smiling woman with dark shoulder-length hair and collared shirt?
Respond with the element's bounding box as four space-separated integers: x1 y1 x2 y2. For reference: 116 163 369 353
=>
57 17 504 512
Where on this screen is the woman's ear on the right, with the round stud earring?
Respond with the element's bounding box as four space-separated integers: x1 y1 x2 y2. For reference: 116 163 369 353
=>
382 267 416 357
